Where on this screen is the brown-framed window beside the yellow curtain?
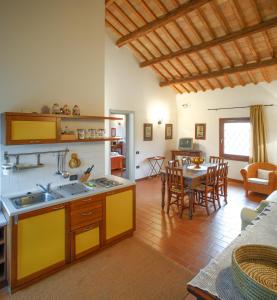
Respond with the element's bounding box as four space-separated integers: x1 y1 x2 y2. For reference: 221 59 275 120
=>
219 118 251 161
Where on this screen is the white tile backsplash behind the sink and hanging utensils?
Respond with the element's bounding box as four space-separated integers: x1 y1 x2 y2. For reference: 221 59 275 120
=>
1 142 105 196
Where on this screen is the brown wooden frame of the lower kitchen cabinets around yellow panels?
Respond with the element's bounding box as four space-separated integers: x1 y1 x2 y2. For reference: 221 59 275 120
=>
7 185 136 292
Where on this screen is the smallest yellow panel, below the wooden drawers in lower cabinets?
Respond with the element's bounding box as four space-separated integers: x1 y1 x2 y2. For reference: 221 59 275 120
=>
75 227 100 255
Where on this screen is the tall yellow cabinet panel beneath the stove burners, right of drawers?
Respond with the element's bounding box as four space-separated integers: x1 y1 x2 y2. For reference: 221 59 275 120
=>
106 190 133 239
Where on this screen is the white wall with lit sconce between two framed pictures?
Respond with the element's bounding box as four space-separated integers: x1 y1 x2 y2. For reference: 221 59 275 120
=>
105 35 177 179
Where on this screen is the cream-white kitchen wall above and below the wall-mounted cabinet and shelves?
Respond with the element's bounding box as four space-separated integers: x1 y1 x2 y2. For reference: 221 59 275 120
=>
0 0 105 194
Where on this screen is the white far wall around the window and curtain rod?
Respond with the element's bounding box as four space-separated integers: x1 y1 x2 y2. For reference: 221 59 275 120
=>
177 81 277 179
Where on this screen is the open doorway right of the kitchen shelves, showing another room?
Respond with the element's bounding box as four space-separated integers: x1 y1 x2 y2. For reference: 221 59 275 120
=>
109 110 135 180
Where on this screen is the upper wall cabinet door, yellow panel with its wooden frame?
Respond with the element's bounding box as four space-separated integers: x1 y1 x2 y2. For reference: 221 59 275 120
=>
7 116 57 144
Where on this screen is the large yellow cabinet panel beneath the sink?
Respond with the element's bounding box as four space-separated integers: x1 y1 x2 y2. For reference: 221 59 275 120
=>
17 209 65 279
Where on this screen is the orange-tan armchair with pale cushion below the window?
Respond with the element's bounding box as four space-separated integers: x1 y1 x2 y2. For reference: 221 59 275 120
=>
240 163 277 196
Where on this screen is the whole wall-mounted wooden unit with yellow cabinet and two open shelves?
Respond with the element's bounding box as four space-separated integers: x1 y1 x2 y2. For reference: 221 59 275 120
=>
4 112 122 145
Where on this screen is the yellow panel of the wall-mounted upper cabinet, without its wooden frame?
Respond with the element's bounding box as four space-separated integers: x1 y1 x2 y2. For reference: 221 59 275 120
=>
11 120 56 141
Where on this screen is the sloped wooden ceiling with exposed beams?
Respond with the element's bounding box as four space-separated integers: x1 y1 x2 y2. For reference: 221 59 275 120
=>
106 0 277 93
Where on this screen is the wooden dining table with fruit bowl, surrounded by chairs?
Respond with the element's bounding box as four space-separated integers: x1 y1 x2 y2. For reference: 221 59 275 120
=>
160 163 216 220
